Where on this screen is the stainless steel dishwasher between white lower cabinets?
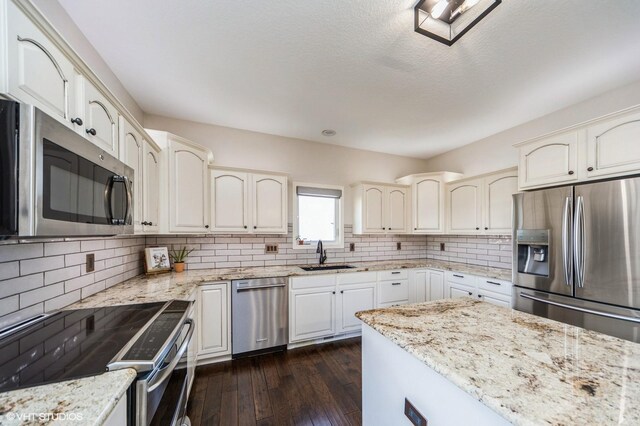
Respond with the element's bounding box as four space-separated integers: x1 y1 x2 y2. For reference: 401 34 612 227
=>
231 277 289 358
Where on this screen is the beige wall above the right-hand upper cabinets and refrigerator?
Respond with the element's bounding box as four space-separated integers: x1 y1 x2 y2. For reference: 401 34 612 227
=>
426 81 640 176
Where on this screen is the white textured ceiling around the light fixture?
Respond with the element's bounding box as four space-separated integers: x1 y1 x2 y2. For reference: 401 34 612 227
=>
59 0 640 158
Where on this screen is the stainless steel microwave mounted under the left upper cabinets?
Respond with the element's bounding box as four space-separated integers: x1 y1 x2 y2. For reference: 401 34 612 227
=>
0 100 134 238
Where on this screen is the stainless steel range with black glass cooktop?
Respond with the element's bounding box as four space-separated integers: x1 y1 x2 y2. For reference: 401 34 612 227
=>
0 301 195 426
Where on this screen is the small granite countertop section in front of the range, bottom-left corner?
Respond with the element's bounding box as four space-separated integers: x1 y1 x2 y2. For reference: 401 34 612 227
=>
0 368 136 426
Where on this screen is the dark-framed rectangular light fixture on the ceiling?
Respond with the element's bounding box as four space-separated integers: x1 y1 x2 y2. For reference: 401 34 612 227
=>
414 0 502 46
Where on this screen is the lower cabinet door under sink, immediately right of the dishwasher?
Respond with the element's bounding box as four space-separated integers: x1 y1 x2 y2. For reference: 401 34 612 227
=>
289 287 336 342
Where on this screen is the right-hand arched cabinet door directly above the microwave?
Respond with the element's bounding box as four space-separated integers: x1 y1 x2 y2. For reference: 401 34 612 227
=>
81 79 118 157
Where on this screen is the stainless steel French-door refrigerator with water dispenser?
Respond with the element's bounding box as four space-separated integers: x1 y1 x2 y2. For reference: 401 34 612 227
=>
513 178 640 342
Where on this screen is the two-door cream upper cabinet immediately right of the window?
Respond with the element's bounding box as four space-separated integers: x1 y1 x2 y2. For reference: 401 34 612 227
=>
353 183 409 234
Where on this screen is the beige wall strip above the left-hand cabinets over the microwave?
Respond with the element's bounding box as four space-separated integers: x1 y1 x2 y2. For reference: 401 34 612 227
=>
32 0 143 123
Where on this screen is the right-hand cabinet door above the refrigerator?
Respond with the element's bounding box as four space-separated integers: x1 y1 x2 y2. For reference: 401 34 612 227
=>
586 112 640 178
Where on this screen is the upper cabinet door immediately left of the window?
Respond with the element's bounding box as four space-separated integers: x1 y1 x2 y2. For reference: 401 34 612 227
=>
251 174 288 234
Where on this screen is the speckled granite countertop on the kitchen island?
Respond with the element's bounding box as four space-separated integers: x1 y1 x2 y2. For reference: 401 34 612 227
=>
356 298 640 425
